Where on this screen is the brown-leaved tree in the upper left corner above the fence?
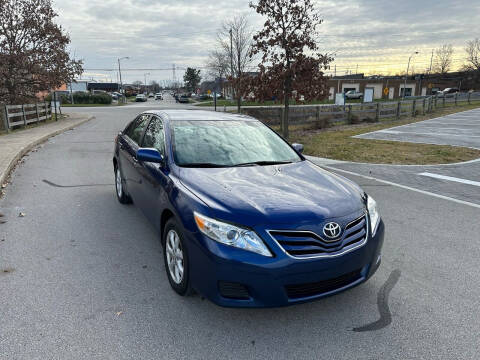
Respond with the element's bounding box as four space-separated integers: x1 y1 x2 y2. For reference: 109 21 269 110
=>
0 0 83 104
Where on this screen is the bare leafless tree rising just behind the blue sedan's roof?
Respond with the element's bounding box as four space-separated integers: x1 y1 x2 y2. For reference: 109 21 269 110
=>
217 15 253 112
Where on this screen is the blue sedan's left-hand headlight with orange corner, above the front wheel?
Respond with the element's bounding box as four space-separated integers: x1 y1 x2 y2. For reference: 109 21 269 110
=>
193 212 272 256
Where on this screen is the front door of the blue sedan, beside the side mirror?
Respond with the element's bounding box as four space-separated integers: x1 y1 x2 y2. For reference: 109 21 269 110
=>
138 115 170 227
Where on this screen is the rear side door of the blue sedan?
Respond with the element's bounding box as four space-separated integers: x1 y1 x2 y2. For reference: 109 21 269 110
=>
119 114 150 202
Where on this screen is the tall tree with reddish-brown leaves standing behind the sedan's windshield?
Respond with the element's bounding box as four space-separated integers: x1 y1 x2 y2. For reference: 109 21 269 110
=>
250 0 333 139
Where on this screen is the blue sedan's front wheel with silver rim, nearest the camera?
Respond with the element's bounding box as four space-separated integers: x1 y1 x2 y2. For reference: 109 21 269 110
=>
163 218 192 296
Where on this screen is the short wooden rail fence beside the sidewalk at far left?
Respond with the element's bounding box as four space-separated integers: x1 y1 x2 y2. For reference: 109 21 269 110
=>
3 103 52 132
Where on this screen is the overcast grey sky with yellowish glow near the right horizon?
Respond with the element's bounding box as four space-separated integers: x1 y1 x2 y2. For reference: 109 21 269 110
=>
54 0 480 82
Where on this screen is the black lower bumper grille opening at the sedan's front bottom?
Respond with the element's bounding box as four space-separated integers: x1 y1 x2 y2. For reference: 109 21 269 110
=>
285 270 362 299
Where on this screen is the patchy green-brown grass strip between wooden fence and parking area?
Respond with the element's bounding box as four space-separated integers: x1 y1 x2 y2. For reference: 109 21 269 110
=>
286 104 480 165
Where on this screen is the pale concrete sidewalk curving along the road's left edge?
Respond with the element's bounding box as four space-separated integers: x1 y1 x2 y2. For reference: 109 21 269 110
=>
0 113 93 186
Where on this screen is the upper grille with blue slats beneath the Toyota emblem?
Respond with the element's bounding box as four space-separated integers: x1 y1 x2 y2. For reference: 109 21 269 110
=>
269 215 367 258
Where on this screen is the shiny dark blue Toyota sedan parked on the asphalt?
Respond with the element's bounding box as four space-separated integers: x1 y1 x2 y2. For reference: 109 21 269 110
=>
113 110 384 307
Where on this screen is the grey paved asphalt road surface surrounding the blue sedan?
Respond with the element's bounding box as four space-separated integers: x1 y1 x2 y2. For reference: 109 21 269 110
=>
0 96 480 359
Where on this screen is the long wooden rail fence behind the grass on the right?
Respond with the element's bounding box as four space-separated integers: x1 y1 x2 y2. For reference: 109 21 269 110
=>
242 92 480 128
